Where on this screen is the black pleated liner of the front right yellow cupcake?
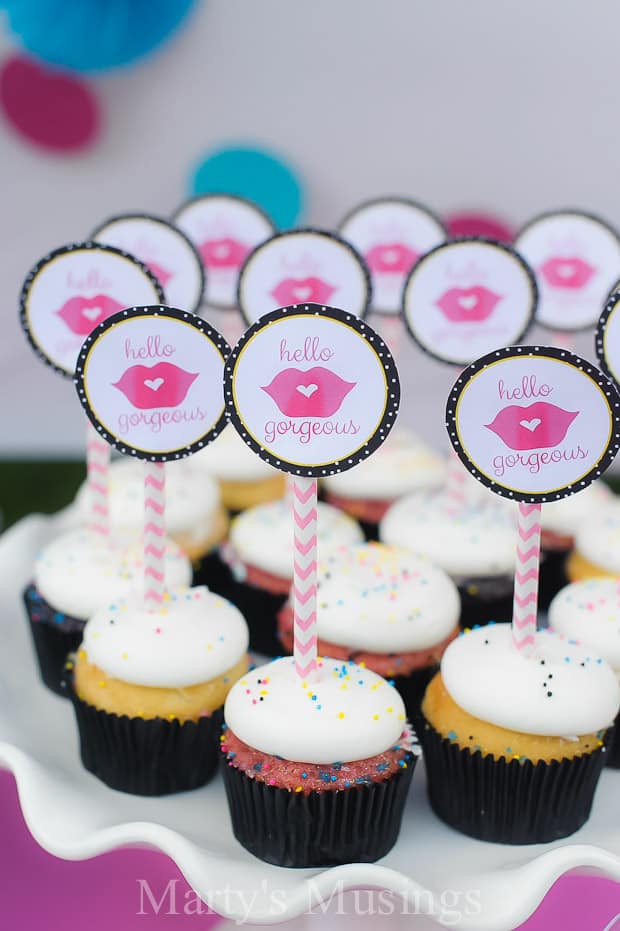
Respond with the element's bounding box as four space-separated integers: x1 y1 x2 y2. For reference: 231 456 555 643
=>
416 720 609 844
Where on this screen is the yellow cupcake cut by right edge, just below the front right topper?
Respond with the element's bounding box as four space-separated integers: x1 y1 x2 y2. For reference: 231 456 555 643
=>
566 496 620 582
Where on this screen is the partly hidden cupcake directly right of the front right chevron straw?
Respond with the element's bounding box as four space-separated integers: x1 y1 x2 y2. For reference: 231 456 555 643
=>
539 481 615 609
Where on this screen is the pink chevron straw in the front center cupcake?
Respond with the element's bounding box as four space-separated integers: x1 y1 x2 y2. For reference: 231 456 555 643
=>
292 476 317 679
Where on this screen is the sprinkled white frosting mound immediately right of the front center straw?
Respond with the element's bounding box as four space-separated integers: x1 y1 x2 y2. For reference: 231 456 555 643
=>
318 543 460 653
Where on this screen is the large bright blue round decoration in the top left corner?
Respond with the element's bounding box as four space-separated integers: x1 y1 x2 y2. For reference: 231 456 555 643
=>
0 0 196 72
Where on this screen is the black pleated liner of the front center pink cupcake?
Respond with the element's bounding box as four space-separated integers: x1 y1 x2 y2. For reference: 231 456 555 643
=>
221 754 416 869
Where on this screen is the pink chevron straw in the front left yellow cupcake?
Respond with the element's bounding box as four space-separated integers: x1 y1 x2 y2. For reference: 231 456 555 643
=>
143 462 166 611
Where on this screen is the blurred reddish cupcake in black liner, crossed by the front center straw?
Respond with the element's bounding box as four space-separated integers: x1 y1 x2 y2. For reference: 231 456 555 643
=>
216 499 363 656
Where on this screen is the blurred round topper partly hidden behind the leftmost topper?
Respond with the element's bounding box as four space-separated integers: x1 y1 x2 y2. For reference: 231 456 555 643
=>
92 213 205 313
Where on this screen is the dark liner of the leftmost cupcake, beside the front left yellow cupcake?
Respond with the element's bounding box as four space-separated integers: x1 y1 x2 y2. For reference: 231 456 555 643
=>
23 584 85 698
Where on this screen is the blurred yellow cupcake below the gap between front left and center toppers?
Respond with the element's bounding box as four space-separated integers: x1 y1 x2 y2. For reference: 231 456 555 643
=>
192 425 286 513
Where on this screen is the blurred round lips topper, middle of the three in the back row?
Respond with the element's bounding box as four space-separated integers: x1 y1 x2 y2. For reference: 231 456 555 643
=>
340 197 448 314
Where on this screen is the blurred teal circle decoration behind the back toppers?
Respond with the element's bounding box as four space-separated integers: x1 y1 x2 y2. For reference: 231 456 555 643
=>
191 146 304 229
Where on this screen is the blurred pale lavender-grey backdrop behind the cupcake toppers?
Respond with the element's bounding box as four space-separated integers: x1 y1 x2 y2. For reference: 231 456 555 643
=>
0 0 620 520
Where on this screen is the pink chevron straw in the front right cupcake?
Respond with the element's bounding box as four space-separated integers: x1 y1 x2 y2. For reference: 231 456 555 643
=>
512 501 541 656
